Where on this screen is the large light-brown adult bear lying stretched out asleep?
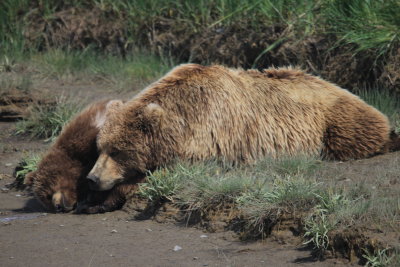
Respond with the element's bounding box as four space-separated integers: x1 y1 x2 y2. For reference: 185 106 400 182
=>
88 64 396 191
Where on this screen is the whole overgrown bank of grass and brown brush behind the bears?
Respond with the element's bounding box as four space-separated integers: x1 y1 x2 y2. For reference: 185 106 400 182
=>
0 0 400 93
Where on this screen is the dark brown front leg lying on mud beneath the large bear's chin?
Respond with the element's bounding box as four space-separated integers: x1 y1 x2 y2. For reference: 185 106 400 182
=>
76 183 137 214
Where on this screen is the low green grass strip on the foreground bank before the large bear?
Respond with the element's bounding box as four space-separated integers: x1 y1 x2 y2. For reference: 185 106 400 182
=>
140 157 400 258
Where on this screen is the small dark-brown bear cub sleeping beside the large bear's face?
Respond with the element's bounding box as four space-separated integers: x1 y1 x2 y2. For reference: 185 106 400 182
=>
25 101 138 213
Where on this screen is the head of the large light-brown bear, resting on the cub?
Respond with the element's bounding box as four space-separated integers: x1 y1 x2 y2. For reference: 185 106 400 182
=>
87 101 165 191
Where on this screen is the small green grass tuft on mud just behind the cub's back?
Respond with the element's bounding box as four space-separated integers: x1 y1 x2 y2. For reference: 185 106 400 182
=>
15 96 82 141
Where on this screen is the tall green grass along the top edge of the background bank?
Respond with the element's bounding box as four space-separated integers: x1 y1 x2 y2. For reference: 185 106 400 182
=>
0 0 400 62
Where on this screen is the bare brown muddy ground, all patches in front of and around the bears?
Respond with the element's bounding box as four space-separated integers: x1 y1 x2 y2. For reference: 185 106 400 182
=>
0 80 400 266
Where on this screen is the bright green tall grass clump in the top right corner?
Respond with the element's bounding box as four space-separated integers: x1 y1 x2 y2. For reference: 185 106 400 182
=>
322 0 400 57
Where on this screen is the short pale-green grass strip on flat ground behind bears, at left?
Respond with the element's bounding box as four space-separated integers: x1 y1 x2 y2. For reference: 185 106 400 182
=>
0 49 171 92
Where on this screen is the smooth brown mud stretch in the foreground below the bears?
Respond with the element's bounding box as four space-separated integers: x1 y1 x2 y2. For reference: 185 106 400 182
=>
0 182 350 266
